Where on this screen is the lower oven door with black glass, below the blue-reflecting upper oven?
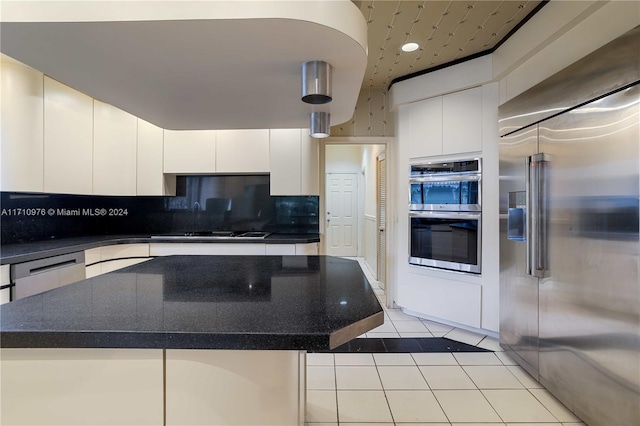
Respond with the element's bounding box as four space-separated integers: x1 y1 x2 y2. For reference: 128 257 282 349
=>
409 211 482 274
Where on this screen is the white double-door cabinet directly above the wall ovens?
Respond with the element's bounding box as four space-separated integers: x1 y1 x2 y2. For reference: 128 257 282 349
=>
408 87 482 158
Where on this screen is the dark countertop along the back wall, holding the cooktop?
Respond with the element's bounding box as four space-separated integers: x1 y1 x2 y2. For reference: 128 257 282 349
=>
0 233 320 265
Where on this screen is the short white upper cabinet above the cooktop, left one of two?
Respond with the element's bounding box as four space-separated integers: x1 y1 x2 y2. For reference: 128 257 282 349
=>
164 130 216 173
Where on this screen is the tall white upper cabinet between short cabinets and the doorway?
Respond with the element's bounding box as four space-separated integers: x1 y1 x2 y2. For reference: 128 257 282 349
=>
270 129 319 195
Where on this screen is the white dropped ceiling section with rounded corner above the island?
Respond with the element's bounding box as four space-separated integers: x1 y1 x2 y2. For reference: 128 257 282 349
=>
0 0 366 130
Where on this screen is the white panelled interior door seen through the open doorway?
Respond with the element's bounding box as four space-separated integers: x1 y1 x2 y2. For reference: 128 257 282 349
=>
326 173 358 256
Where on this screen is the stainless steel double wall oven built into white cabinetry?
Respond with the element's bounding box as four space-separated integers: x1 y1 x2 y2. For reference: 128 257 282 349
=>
409 158 482 274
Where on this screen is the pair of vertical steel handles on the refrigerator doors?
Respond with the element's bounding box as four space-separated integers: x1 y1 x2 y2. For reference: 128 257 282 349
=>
526 153 548 277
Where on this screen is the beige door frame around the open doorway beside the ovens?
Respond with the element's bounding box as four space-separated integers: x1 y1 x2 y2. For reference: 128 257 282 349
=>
318 136 397 308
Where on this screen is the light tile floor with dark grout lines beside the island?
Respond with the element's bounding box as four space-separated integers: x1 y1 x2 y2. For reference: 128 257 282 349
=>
306 259 584 426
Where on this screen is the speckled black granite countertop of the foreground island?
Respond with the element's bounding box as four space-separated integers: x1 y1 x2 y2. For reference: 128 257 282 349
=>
0 256 384 350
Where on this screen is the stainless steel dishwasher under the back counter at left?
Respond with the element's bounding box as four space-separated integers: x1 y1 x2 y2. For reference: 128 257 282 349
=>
11 251 85 300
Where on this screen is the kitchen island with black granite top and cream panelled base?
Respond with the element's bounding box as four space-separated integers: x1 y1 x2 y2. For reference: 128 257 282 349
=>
0 256 383 425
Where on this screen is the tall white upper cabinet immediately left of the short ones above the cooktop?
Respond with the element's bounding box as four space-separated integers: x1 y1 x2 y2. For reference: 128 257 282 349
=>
136 119 176 195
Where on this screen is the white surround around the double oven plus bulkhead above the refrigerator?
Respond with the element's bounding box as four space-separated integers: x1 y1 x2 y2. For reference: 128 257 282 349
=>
389 1 640 332
